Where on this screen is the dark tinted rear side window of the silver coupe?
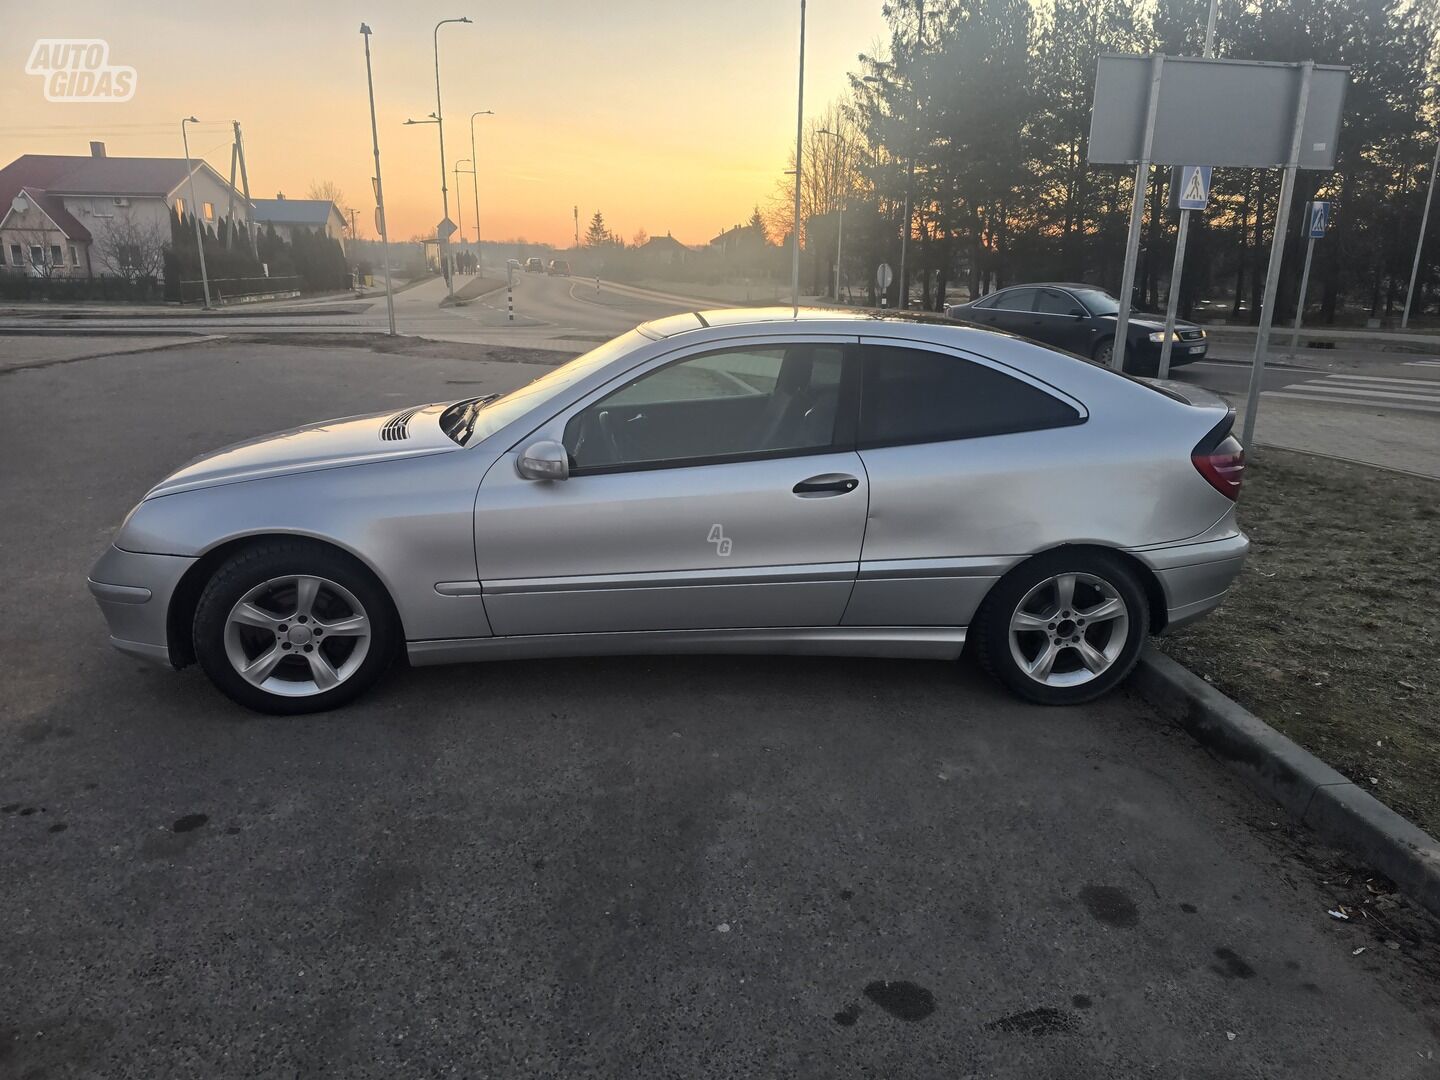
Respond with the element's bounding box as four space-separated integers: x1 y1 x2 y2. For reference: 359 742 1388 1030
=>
860 346 1083 446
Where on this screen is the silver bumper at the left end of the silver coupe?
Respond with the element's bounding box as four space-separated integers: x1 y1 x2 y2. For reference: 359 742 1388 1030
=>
88 544 196 664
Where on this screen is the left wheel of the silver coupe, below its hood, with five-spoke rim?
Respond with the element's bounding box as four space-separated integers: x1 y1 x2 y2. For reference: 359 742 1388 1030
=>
193 540 400 716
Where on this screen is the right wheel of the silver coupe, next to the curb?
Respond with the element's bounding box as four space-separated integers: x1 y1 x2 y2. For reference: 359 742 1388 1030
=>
972 549 1149 706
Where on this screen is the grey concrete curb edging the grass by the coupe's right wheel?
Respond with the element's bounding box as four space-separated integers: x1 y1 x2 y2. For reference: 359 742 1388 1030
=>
1130 645 1440 917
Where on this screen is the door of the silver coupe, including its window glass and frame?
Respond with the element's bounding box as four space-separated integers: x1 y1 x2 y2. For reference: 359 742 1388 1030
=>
475 337 870 635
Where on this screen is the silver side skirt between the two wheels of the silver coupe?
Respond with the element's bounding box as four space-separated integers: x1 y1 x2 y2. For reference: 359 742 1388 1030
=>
406 626 965 667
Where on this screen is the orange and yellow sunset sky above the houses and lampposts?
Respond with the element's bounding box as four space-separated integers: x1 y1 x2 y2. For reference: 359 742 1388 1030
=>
0 0 884 243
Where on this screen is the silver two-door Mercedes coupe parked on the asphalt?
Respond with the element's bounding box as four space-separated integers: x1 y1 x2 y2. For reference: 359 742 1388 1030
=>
89 308 1248 713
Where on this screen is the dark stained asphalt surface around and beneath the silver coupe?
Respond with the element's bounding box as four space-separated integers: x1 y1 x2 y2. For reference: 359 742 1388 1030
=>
0 334 1440 1080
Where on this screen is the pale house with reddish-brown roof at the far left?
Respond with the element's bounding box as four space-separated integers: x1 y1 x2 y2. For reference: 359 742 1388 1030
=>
0 143 251 276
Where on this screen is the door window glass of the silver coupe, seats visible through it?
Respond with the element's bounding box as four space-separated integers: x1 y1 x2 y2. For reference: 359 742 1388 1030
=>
564 344 845 472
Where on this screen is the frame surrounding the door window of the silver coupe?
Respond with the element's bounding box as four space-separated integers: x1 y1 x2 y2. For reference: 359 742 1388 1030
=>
529 333 860 478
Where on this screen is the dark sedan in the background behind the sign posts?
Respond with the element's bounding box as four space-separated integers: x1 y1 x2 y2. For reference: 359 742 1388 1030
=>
945 282 1208 374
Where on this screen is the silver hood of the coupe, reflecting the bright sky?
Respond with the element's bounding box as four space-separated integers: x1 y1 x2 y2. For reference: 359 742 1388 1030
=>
145 402 459 498
